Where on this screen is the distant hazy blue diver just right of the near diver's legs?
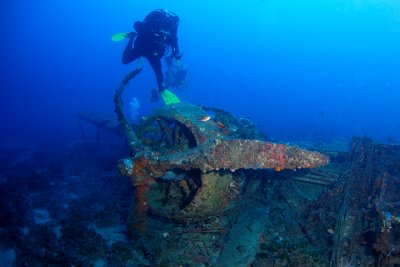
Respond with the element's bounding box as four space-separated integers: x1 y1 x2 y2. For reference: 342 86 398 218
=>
164 55 188 89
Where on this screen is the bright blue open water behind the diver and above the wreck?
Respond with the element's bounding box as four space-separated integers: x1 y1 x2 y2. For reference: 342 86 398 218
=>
0 0 400 147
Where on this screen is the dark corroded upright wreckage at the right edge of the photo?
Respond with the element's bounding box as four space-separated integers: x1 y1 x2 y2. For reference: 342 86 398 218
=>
325 138 400 266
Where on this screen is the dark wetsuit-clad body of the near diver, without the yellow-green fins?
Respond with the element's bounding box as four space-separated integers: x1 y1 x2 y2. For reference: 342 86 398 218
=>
122 9 181 92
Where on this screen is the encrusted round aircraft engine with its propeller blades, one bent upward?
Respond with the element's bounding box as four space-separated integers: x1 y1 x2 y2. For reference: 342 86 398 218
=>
114 69 328 233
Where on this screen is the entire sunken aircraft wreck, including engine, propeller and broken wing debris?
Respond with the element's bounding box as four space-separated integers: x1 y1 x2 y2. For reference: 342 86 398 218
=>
75 70 400 266
